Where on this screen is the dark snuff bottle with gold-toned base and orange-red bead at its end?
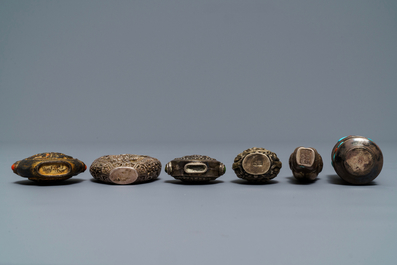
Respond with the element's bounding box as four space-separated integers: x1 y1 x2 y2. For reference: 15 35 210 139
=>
11 152 87 182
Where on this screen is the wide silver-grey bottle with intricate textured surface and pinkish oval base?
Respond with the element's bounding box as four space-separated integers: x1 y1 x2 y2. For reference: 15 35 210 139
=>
90 154 161 184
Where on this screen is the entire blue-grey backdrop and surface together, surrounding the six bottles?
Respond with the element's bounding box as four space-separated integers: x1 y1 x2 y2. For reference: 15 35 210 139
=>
0 0 397 265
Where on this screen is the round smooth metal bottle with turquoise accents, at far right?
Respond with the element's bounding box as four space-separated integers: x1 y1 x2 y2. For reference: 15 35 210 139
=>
331 135 383 184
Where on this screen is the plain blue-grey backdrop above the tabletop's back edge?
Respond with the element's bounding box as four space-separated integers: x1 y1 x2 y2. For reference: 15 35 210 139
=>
0 0 397 143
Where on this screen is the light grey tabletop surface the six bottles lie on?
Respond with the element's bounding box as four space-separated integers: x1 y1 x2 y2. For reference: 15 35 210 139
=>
0 142 397 264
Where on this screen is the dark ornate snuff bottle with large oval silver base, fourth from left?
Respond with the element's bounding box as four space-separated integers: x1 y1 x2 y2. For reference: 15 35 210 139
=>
232 147 282 182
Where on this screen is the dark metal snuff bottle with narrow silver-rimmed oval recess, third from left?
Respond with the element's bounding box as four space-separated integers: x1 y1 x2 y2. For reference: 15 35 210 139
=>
165 155 226 182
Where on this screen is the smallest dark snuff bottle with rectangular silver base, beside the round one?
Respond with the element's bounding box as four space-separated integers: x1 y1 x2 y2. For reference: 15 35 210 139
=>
289 146 323 181
